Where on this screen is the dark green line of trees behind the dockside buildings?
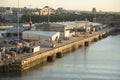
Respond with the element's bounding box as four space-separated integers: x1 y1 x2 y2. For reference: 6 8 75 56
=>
21 12 120 23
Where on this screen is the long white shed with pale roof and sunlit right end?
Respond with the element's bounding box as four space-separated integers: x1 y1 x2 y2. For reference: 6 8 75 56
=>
22 31 60 41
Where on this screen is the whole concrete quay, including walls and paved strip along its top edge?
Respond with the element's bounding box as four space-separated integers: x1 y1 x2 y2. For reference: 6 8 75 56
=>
0 29 110 72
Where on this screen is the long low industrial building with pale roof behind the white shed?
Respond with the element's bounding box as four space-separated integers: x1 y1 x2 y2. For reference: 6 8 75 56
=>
35 21 91 37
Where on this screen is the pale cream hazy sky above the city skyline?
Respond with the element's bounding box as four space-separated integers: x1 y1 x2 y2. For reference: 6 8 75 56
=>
0 0 120 12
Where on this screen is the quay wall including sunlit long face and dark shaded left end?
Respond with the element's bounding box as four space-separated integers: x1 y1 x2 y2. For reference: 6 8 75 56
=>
0 31 108 72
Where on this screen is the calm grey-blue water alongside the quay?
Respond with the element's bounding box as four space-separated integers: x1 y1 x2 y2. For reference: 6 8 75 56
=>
0 35 120 80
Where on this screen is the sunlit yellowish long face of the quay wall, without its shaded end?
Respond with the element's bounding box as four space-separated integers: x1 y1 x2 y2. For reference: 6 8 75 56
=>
20 32 107 71
